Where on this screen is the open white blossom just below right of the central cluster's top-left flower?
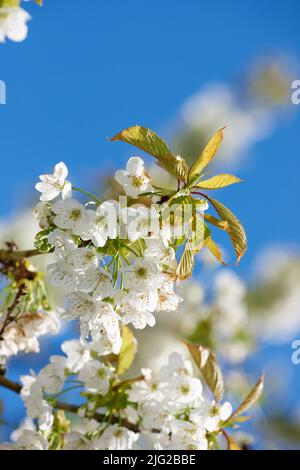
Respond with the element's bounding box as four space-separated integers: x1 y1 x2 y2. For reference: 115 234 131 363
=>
52 199 89 235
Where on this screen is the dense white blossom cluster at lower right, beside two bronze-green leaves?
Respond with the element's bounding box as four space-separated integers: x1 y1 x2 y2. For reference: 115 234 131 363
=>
129 353 232 450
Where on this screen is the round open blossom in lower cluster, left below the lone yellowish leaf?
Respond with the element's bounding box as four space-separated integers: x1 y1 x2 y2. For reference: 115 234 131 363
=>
78 359 113 395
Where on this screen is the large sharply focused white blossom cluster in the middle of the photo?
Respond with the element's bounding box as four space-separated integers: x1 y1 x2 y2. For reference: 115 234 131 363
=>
35 157 186 346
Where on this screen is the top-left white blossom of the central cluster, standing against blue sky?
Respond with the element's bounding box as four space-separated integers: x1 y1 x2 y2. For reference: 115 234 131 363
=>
35 162 72 201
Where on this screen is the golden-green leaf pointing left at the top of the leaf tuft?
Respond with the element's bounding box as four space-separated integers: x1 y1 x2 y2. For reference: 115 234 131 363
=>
111 126 188 182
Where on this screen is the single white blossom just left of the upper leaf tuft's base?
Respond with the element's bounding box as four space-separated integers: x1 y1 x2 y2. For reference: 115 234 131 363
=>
115 157 152 197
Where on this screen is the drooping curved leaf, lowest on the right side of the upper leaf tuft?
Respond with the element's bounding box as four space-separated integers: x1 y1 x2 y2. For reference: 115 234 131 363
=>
207 197 247 264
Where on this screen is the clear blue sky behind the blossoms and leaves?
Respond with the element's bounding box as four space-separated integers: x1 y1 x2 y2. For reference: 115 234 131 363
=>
0 0 300 444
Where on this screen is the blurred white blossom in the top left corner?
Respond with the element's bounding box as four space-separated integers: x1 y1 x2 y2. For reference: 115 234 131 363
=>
0 7 31 42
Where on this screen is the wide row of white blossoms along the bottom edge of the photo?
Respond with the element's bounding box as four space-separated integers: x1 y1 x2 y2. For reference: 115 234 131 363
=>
6 339 232 450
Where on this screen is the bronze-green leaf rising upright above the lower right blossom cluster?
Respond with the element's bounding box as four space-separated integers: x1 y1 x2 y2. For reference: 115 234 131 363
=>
185 342 224 401
